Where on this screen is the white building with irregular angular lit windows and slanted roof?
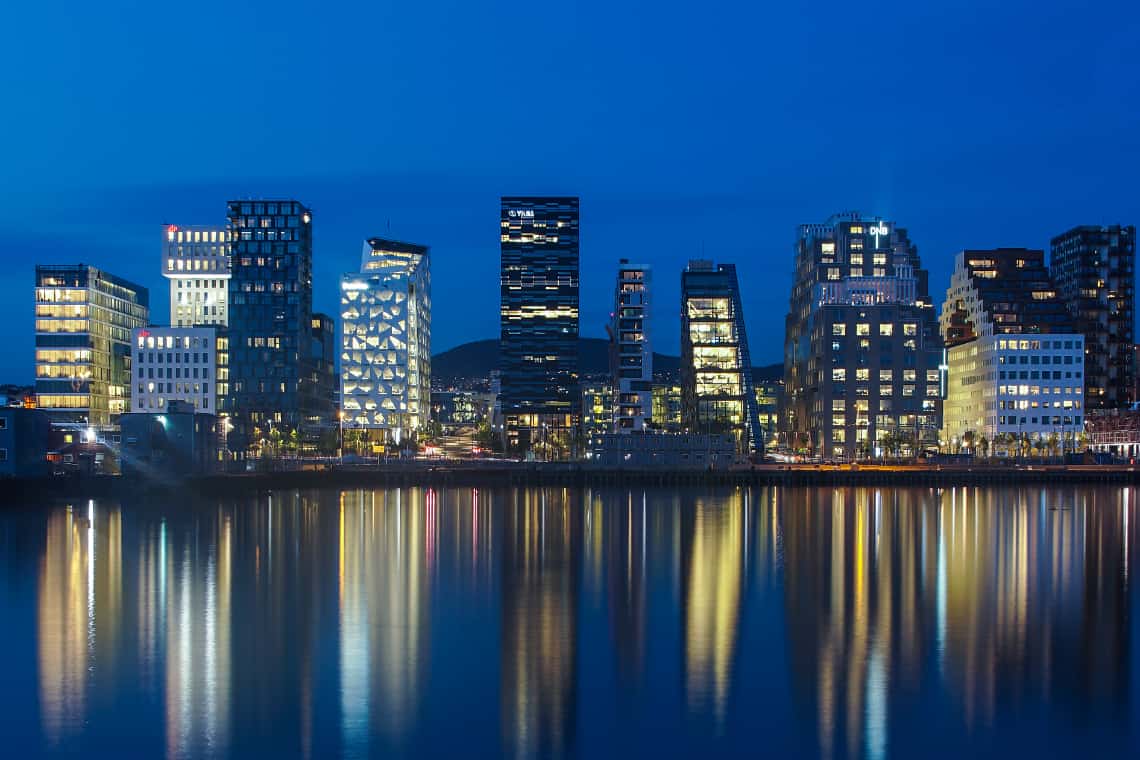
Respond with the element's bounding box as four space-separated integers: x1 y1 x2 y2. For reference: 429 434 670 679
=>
341 238 431 442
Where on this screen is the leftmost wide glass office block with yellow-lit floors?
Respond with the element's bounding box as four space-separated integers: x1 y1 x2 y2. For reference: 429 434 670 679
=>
35 264 149 427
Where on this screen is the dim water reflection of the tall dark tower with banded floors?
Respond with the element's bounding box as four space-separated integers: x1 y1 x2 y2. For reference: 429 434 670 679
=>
498 489 583 757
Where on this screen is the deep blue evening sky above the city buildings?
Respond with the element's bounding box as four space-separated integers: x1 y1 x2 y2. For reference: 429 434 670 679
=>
0 0 1140 382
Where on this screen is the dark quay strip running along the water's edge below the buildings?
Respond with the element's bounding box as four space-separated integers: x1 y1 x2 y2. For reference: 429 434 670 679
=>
0 463 1140 504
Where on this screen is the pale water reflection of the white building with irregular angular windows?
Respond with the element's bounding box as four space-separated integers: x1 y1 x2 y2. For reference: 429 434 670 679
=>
337 489 439 754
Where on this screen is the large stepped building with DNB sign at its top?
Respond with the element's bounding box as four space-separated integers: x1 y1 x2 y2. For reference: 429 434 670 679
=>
780 213 942 459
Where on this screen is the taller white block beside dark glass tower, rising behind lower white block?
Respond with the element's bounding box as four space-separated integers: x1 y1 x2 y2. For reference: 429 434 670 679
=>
162 224 230 327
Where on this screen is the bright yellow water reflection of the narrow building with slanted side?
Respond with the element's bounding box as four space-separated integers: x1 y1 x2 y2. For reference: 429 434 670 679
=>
681 490 747 728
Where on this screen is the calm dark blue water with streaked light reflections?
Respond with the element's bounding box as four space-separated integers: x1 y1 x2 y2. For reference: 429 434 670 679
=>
0 488 1140 758
